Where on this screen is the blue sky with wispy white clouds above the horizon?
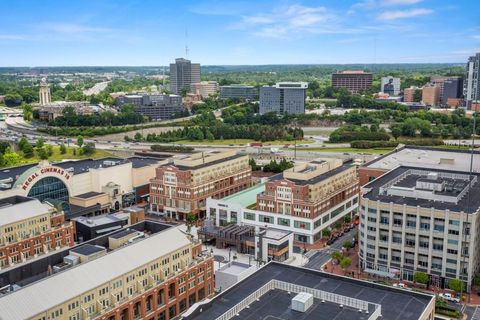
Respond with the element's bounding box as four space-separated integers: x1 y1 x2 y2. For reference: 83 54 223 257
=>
0 0 480 66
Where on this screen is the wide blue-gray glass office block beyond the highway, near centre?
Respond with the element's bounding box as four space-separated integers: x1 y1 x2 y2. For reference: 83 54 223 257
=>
260 82 308 114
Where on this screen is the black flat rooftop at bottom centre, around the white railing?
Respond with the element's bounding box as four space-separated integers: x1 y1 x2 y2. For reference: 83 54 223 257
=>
186 262 434 320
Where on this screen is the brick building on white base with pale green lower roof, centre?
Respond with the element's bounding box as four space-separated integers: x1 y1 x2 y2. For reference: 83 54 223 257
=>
207 159 358 244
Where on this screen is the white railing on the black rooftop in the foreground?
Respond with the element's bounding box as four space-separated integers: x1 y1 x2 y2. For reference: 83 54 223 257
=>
216 280 381 320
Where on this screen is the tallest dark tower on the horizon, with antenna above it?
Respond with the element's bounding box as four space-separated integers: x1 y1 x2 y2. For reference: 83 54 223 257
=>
170 58 200 94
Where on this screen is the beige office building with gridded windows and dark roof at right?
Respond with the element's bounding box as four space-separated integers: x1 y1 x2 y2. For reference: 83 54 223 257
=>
359 166 480 290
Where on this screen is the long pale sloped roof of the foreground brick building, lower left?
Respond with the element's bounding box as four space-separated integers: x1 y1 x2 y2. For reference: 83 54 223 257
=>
0 227 190 320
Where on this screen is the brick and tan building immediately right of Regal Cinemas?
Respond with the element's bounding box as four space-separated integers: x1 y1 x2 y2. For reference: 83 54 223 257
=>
150 150 252 220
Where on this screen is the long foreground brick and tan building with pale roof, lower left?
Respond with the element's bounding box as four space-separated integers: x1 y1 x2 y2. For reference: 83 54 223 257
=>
0 227 214 320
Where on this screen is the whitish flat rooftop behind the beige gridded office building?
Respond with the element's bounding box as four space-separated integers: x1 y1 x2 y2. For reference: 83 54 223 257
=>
365 146 480 172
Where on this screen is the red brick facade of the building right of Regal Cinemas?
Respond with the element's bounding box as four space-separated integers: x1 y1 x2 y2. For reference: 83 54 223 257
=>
150 165 252 220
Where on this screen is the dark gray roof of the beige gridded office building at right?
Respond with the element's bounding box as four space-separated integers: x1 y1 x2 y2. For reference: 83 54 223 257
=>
363 166 480 213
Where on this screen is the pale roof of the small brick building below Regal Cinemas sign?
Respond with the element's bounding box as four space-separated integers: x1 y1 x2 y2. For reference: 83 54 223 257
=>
0 199 51 226
